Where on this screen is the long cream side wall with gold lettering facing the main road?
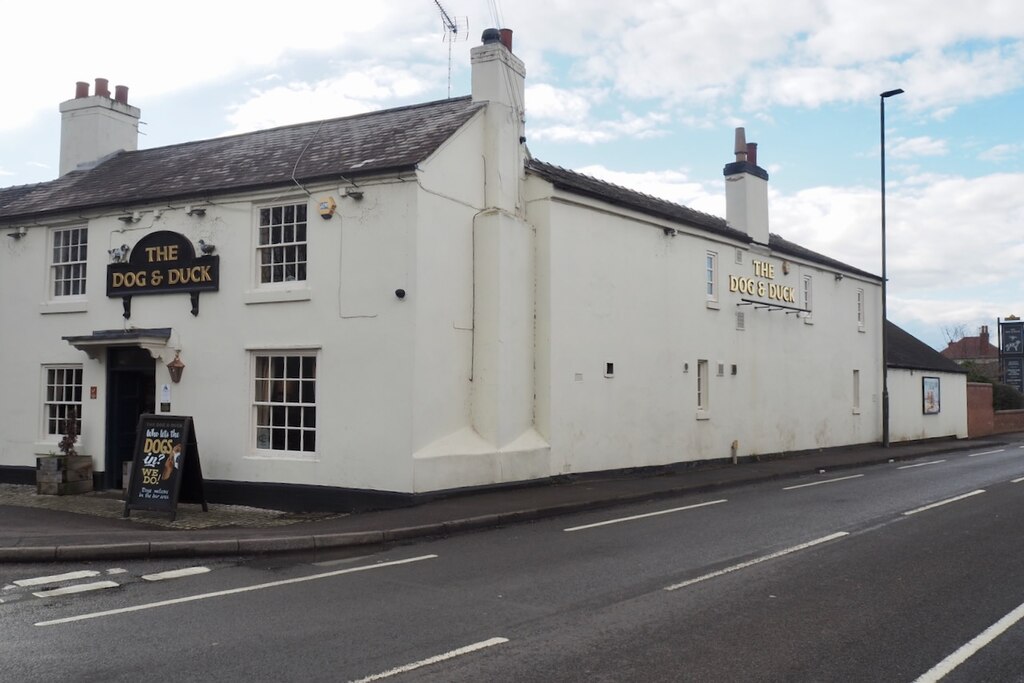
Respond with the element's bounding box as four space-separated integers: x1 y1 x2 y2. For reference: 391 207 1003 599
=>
530 187 881 472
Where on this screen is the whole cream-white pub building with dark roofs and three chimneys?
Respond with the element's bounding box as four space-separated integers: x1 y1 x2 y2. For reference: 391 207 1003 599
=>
0 30 966 509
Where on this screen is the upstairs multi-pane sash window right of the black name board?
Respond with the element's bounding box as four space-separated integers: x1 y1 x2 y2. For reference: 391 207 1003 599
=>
256 203 307 285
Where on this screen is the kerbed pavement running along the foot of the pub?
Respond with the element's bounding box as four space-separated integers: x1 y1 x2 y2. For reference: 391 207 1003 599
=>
0 434 1024 562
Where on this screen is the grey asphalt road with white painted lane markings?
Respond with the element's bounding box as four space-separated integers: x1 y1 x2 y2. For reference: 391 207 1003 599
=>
0 444 1024 682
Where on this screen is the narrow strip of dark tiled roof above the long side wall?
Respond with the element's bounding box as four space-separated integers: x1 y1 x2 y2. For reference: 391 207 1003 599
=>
526 159 882 282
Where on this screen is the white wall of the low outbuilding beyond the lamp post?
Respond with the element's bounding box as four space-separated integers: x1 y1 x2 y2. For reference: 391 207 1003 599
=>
889 368 968 441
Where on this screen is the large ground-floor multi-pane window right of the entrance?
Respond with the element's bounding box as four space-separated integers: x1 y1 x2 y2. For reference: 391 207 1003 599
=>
253 351 316 455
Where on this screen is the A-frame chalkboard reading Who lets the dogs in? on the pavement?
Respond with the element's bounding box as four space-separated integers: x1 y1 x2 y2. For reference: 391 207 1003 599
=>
125 415 208 521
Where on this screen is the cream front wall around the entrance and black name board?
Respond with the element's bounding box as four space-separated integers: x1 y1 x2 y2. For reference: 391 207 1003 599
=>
0 182 416 490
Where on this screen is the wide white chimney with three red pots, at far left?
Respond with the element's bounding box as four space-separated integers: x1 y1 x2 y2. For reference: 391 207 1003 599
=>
59 78 140 175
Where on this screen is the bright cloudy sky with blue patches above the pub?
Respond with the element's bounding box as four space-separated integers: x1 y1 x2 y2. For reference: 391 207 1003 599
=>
0 0 1024 348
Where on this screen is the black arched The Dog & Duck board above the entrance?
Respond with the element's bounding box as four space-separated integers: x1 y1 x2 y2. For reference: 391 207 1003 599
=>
106 230 220 317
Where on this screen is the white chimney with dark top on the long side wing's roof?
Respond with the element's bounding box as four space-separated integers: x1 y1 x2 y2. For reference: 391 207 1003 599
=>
724 128 768 245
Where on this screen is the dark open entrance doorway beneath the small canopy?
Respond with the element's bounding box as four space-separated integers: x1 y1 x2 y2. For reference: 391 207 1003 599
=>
103 346 157 488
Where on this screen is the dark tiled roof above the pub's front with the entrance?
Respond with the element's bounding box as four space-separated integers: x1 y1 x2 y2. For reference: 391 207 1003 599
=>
0 96 483 221
